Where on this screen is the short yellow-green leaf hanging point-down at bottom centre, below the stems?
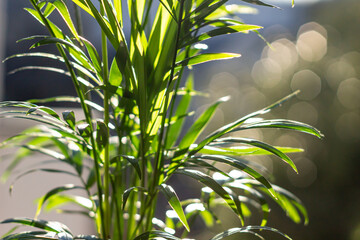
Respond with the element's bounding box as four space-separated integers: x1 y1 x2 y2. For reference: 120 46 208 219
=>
159 183 190 232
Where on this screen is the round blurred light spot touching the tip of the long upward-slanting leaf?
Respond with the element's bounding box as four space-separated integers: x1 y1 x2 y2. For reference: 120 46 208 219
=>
291 69 321 100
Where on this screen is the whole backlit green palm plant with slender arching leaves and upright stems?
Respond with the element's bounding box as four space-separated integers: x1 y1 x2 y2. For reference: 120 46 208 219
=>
0 0 321 240
